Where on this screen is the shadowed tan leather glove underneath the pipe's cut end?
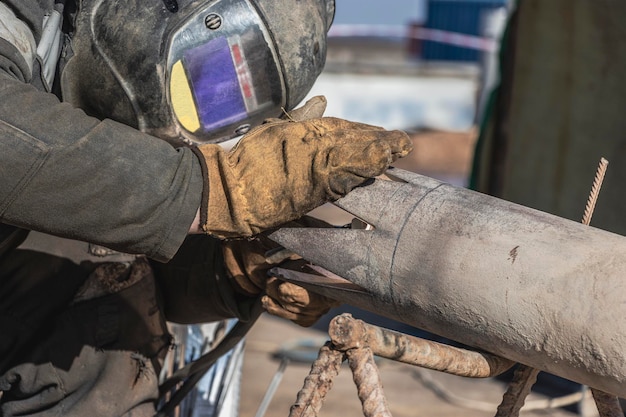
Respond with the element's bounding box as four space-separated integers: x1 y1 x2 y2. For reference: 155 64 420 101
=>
222 217 339 327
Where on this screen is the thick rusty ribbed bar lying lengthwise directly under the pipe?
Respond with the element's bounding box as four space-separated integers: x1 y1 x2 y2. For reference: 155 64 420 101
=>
328 314 515 378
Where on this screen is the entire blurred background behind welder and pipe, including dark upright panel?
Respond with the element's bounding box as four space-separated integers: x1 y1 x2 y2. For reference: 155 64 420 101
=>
173 0 626 417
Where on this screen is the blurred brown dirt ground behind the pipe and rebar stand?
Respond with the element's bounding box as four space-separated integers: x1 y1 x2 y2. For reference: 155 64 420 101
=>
240 130 576 417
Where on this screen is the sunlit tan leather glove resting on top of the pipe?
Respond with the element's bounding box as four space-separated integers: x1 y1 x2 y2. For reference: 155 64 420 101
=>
197 95 412 239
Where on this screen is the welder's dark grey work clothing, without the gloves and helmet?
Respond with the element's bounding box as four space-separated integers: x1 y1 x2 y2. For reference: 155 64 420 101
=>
0 0 251 416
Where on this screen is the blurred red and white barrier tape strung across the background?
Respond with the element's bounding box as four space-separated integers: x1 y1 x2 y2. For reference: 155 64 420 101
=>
328 25 498 52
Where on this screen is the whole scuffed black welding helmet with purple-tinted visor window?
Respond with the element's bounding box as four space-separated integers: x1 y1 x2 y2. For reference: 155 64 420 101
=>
61 0 335 144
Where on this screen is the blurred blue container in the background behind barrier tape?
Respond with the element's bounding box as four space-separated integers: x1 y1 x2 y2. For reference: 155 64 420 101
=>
421 0 507 62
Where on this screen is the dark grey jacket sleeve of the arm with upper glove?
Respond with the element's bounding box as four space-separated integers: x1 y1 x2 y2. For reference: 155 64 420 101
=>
0 35 204 261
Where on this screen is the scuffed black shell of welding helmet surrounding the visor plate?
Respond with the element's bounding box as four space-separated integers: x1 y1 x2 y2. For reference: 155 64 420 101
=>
61 0 334 145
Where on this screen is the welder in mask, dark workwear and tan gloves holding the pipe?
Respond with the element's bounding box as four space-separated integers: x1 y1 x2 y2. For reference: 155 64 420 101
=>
0 0 411 416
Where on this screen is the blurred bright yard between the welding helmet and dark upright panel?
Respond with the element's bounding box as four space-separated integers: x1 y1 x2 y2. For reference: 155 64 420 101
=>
310 0 508 184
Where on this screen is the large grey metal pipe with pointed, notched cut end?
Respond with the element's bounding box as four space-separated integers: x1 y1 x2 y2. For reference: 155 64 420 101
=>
271 169 626 397
